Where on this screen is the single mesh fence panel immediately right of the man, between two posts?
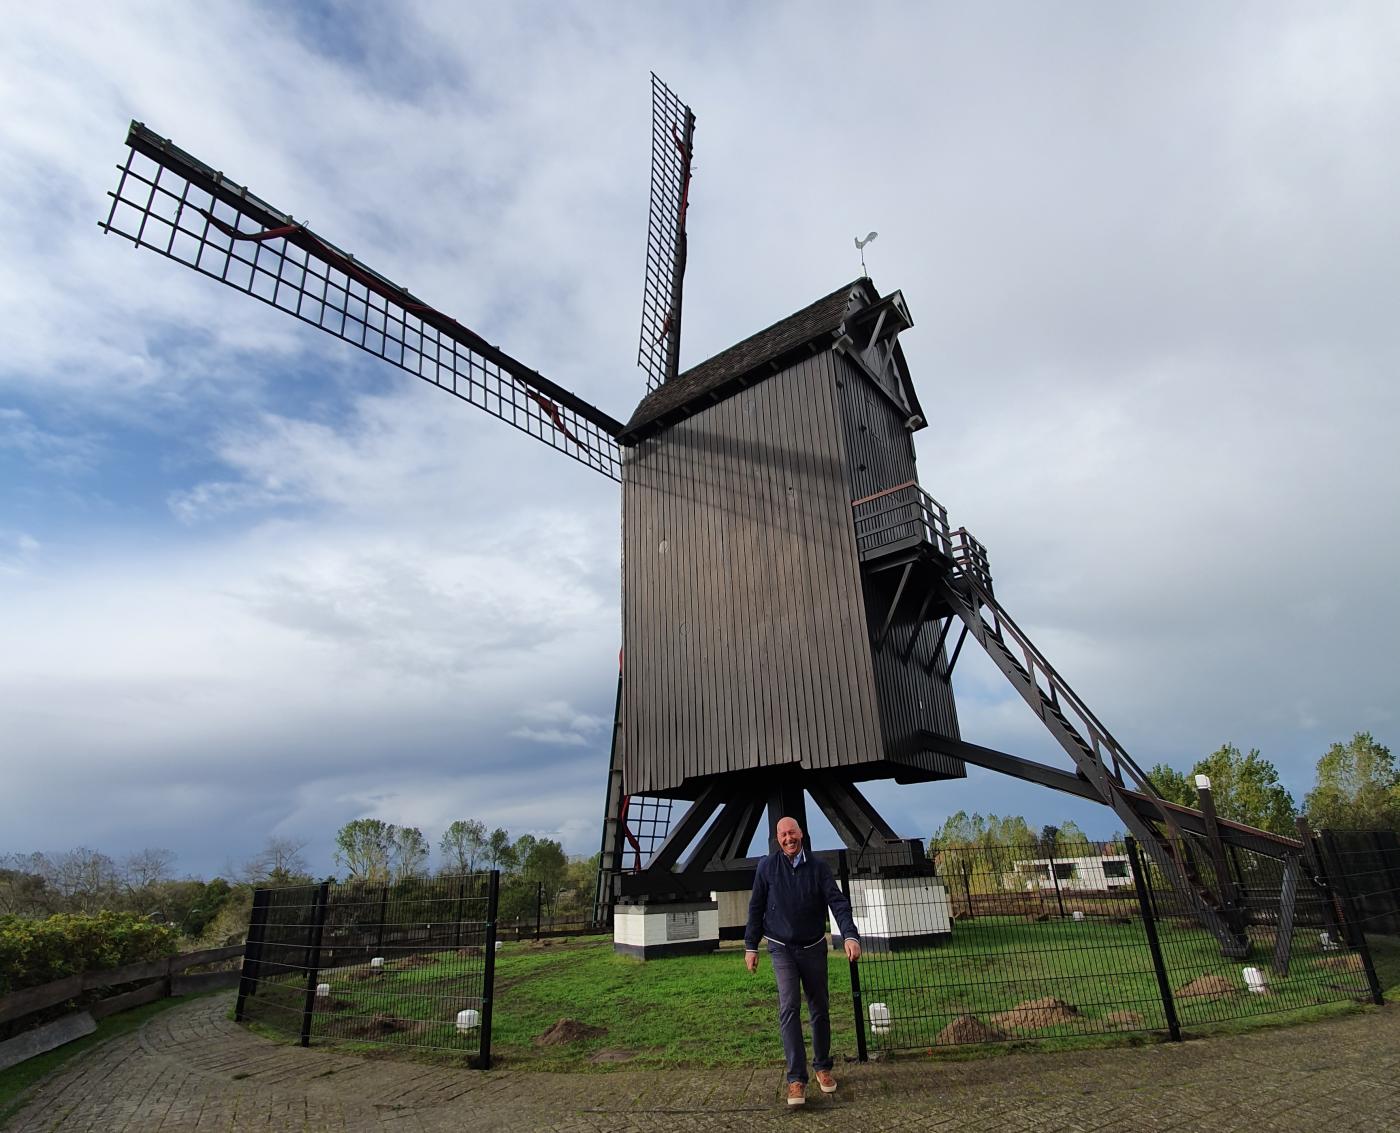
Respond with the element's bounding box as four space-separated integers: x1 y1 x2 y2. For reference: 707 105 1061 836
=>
851 846 1166 1050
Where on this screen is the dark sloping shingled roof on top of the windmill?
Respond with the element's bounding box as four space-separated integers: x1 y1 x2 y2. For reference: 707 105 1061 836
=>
617 279 879 444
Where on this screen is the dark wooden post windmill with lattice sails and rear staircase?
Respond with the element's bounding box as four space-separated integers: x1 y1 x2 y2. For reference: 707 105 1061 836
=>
101 76 1301 955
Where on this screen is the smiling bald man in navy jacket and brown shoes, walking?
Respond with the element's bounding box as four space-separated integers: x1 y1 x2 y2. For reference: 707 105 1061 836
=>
743 818 861 1105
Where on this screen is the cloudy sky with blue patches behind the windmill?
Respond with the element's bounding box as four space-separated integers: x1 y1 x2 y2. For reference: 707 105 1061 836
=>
0 0 1400 877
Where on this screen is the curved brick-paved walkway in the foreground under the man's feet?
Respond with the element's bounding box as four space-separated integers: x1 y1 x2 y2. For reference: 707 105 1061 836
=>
8 996 1400 1133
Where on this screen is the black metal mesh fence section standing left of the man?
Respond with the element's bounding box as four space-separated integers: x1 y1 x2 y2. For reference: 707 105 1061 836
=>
235 871 500 1069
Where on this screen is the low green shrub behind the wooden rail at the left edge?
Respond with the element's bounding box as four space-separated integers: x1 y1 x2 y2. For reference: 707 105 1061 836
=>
0 912 179 996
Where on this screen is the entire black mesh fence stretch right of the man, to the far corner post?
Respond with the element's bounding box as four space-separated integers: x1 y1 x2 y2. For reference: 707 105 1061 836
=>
843 839 1380 1055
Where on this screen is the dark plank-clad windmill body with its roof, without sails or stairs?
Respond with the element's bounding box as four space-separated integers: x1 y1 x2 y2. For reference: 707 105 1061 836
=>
607 279 965 895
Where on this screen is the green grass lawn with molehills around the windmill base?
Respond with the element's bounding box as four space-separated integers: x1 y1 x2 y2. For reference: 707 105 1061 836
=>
240 917 1400 1070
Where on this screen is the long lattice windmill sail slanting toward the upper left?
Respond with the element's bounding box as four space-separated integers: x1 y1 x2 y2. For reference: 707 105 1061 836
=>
101 122 623 480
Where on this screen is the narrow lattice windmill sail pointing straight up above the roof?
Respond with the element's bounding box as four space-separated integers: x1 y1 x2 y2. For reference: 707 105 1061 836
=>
637 74 696 391
